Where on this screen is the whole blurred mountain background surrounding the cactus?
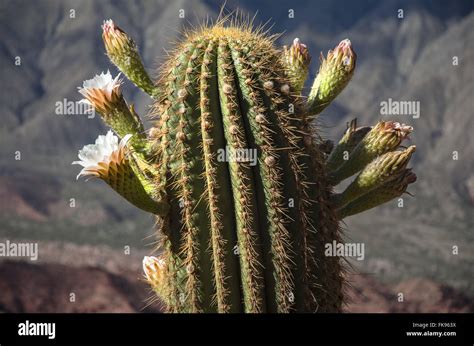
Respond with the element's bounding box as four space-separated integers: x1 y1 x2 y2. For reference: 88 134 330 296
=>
0 0 474 312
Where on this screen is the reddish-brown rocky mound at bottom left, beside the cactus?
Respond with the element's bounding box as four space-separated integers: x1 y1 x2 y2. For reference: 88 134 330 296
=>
0 262 159 313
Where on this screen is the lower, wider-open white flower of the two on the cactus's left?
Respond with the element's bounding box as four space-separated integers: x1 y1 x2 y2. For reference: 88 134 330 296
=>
72 130 132 179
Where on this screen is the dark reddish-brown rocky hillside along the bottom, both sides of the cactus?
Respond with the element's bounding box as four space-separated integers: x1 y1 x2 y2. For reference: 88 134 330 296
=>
0 261 474 313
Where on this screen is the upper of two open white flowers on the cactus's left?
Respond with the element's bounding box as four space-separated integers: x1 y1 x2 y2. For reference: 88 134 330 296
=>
78 70 123 112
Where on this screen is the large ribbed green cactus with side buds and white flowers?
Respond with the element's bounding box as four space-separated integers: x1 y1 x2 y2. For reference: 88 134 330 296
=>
75 16 416 313
